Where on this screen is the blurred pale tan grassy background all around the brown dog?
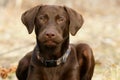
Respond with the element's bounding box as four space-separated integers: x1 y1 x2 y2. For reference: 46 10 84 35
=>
0 0 120 80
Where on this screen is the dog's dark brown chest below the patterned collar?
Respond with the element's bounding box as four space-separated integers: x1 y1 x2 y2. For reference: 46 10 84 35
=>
29 52 80 80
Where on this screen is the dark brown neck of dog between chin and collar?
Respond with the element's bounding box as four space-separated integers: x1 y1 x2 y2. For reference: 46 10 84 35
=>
37 37 69 60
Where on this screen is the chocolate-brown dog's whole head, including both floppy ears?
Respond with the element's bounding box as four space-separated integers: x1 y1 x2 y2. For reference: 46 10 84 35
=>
22 5 83 46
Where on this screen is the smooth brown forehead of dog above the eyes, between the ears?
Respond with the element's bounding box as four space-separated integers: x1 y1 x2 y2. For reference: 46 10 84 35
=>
39 5 66 15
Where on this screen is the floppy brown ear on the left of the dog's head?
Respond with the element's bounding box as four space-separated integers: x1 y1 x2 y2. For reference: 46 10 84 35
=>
21 6 41 34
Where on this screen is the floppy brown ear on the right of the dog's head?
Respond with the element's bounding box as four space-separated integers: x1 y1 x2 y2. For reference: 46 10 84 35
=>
64 7 84 36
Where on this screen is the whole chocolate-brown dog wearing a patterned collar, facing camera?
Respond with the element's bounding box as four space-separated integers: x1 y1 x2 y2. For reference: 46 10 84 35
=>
16 5 95 80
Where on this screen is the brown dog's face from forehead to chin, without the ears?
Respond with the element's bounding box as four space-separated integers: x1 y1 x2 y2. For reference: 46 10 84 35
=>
35 6 69 46
